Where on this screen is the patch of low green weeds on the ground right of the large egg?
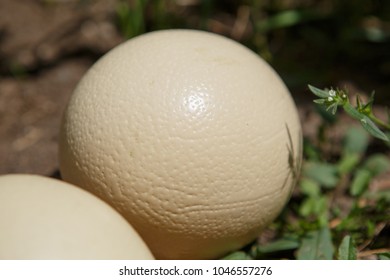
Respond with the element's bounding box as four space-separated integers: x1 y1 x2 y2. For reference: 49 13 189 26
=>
221 95 390 260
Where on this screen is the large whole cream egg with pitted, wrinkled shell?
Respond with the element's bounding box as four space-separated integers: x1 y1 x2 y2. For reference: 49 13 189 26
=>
60 30 302 259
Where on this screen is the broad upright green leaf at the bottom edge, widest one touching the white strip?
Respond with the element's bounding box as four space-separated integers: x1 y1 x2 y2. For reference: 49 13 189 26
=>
297 227 334 260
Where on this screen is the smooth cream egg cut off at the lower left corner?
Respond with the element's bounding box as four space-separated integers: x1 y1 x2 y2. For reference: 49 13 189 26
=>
0 174 154 259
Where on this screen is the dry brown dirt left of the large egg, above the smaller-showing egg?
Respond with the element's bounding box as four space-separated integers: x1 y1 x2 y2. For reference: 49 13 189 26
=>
0 0 123 176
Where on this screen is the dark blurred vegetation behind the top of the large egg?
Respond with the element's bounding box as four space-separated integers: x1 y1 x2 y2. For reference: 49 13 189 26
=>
112 0 390 102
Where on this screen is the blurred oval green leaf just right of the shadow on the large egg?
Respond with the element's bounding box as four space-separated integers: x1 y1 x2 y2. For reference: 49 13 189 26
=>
303 161 339 188
